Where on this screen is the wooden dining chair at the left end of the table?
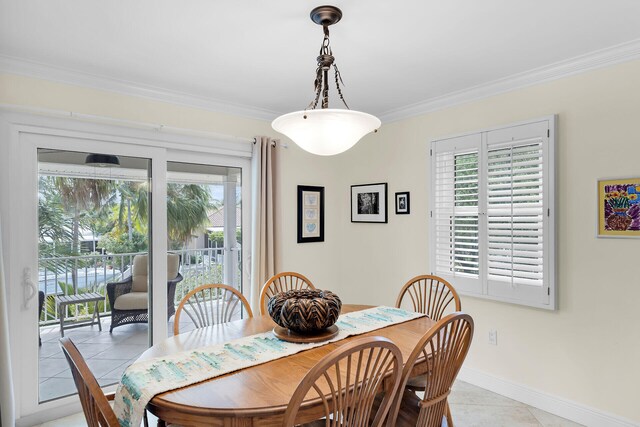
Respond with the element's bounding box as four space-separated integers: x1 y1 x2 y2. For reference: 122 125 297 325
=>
60 337 149 427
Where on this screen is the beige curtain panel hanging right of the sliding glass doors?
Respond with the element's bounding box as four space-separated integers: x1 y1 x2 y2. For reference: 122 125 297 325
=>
250 136 278 313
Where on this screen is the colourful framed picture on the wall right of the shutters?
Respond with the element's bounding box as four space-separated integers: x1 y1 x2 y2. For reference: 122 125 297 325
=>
598 178 640 237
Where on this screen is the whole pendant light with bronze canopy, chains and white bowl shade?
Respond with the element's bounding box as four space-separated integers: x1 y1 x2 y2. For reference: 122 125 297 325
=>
271 6 381 156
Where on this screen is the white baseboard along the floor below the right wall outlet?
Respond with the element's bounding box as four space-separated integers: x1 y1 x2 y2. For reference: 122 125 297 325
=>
458 367 640 427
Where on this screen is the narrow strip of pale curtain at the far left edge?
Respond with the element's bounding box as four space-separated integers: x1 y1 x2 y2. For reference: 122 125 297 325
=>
0 217 15 427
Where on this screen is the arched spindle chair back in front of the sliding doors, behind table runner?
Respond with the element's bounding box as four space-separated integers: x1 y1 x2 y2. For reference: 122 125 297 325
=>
173 284 253 335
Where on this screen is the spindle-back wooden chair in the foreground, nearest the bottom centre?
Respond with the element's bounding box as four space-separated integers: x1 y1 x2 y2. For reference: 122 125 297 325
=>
283 336 402 427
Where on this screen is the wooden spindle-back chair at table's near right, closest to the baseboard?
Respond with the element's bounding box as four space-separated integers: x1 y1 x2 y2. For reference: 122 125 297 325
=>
389 312 473 427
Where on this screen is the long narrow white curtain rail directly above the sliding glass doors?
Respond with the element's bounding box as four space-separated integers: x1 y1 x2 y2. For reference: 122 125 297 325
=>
0 103 255 142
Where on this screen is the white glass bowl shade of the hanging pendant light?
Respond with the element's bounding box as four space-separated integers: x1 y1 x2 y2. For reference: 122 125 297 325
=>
271 108 381 156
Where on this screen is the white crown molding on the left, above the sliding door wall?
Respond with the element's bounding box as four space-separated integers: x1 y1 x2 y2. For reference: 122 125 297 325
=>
0 55 280 121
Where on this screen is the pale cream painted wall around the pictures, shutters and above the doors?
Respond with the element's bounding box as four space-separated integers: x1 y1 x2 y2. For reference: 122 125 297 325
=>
5 57 640 422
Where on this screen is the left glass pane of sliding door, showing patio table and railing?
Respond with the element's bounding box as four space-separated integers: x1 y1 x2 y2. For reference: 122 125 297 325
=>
34 148 153 402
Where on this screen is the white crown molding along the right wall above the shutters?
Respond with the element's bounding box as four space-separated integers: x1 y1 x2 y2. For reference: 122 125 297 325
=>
380 39 640 123
